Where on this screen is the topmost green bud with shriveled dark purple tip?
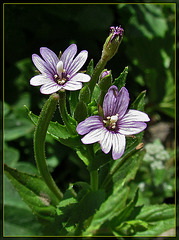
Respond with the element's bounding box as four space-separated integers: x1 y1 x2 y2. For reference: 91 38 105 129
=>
101 26 124 61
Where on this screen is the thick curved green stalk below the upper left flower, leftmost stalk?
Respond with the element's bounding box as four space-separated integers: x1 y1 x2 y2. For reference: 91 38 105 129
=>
34 94 63 200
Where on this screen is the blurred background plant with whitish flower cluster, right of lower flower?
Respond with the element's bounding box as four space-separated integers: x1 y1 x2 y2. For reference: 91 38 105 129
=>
131 139 175 204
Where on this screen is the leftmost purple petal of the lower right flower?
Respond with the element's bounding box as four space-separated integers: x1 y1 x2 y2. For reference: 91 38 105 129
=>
76 116 103 135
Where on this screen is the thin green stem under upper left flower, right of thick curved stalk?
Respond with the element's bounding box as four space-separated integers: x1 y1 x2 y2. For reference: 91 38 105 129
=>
59 92 76 135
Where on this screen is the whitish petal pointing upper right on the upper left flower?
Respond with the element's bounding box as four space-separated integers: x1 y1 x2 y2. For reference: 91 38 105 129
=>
68 50 88 76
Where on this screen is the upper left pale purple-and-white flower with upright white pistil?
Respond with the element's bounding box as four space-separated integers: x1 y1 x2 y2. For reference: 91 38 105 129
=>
30 44 90 94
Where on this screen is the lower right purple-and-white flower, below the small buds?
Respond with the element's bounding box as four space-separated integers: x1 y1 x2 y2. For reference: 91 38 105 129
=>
77 86 150 160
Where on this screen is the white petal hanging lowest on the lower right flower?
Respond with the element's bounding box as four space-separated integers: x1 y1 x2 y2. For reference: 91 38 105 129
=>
112 133 126 160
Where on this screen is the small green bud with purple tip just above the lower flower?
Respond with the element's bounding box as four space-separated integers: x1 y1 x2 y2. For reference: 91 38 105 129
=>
98 69 112 92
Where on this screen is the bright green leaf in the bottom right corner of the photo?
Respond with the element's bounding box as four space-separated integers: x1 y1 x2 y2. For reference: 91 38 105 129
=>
134 204 175 237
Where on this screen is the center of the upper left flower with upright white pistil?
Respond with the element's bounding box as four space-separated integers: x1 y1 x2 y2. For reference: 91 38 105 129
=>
53 61 70 85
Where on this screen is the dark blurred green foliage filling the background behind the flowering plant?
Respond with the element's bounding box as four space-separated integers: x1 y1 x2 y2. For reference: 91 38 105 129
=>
4 4 178 236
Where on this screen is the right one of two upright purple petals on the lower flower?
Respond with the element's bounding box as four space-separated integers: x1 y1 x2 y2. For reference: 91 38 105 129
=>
114 87 129 119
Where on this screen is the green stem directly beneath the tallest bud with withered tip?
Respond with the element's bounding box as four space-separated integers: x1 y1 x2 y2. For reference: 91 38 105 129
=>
88 58 107 100
